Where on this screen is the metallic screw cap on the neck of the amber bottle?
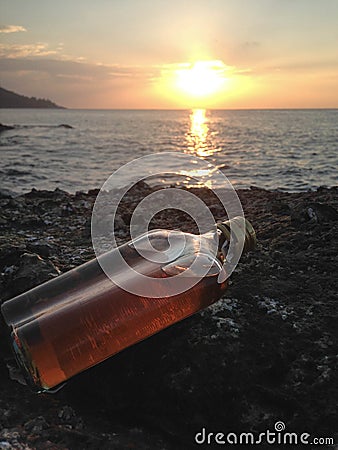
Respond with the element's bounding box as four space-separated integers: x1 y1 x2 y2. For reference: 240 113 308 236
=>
216 216 257 252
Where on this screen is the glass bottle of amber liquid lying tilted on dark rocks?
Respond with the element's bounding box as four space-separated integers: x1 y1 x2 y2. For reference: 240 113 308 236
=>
1 218 255 392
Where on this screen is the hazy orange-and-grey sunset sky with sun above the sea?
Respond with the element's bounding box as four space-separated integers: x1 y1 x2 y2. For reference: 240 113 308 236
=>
0 0 338 109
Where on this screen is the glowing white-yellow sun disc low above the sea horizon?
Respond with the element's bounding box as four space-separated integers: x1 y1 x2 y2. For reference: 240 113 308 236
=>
175 61 227 98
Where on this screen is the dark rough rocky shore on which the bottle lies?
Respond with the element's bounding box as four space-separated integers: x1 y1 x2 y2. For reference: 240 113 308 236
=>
0 183 338 450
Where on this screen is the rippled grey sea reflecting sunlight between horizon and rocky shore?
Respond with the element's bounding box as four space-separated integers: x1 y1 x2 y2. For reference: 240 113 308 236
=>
0 109 338 193
